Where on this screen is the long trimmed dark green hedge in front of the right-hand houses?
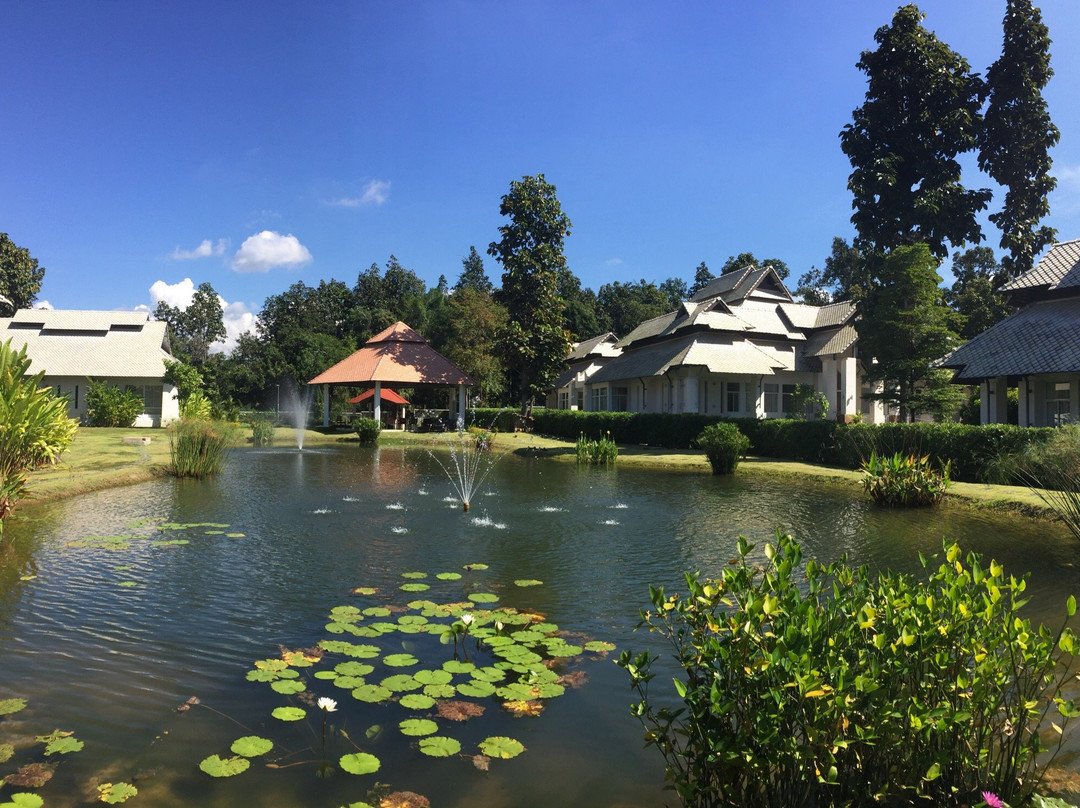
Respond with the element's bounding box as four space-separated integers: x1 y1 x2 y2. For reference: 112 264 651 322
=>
469 408 1053 482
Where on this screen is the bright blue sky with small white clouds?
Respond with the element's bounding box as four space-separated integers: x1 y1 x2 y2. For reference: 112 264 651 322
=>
0 0 1080 349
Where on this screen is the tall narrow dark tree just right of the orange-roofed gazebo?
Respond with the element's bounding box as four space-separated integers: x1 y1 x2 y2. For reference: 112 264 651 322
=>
487 174 570 415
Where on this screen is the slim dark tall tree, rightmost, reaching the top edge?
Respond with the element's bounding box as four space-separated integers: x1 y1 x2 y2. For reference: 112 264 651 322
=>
978 0 1061 278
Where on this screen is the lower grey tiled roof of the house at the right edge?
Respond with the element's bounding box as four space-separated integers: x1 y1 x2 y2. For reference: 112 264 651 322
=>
940 297 1080 382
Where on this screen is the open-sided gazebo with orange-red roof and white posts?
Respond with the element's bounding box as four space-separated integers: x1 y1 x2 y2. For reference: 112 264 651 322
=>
308 322 476 427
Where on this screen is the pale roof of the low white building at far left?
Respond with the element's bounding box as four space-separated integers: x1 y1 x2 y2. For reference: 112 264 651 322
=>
0 309 173 380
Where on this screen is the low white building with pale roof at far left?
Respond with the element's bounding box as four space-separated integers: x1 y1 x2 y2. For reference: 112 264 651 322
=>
0 309 180 427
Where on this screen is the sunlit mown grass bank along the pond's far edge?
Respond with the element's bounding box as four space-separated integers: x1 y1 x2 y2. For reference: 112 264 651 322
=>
23 427 1052 517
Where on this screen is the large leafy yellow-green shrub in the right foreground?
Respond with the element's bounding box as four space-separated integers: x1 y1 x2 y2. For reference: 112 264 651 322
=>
619 534 1080 808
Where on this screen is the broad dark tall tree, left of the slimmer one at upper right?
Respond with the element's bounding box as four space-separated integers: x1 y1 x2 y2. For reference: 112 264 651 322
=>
840 5 991 258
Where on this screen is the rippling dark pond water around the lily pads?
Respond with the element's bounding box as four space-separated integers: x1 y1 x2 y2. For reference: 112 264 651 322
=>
0 447 1080 808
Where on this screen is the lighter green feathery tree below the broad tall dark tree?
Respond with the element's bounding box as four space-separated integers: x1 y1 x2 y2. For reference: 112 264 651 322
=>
855 244 959 421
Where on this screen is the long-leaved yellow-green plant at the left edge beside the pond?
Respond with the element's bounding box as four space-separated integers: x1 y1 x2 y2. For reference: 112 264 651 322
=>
0 339 79 534
